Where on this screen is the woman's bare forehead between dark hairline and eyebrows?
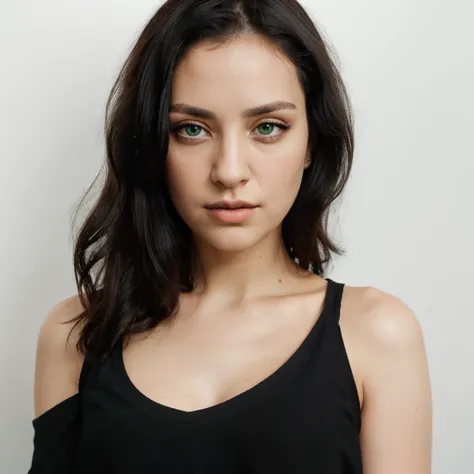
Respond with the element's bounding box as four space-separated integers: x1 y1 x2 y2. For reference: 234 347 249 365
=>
172 35 304 110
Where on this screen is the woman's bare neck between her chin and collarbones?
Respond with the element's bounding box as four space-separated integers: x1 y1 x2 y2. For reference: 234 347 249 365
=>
191 231 301 301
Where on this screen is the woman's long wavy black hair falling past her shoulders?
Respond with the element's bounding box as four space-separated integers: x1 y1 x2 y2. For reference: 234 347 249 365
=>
69 0 354 359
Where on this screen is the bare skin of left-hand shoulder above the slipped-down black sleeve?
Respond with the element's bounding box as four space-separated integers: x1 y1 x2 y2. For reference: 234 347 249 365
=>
35 296 83 417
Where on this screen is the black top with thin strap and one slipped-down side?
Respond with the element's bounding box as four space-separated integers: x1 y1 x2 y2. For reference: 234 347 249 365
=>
30 279 362 474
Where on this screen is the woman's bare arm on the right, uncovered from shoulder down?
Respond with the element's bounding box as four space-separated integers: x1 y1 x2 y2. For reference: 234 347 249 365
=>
361 292 432 474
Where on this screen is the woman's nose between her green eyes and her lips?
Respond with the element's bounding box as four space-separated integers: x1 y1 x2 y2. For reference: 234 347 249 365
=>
211 137 251 188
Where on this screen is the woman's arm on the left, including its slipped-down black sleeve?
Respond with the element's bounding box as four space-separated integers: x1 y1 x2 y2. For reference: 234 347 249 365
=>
29 297 84 474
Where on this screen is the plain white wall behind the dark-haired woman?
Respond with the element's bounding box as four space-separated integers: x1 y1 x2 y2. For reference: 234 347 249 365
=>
0 0 474 474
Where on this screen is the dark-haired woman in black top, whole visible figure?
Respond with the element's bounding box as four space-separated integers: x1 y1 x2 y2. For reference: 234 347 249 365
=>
30 0 431 474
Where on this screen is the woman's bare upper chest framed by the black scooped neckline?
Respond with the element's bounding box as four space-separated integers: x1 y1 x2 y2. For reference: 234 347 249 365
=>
124 288 330 411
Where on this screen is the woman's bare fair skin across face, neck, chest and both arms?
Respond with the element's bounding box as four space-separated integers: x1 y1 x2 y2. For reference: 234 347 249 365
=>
35 36 431 474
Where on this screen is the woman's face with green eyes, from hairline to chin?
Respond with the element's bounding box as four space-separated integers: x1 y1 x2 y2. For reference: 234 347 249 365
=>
167 36 309 252
